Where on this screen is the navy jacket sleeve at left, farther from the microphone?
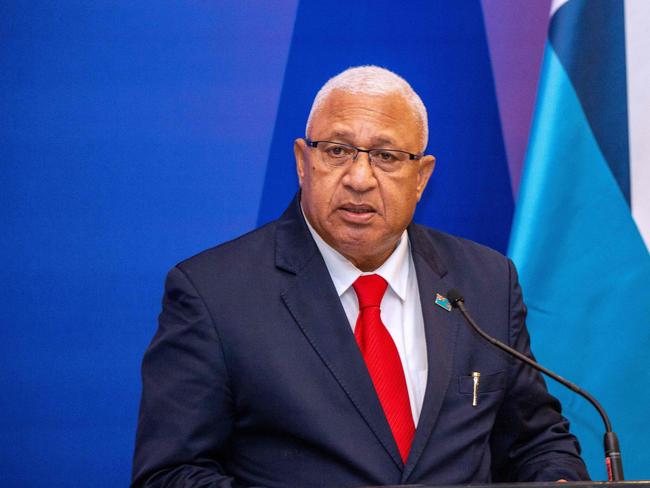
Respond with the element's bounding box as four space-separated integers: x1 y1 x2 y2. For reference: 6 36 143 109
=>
132 268 242 487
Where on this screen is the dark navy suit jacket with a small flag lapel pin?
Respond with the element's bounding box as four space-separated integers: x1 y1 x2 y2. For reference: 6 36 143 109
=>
133 199 587 487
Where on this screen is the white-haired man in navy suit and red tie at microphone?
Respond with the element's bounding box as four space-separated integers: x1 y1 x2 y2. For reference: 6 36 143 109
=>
133 67 587 487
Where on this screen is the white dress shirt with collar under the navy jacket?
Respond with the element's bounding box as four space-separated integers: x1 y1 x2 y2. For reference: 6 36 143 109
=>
305 218 427 426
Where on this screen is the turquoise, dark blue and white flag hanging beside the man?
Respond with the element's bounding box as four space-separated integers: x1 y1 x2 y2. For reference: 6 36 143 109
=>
509 0 650 479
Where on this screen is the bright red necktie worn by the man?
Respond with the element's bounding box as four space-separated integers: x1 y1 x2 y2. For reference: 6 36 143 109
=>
352 275 415 463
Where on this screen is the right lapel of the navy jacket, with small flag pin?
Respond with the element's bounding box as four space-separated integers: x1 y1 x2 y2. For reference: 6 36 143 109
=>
402 225 460 483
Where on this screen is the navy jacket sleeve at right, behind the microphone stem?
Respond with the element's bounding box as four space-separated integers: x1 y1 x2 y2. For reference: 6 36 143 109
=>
491 260 589 482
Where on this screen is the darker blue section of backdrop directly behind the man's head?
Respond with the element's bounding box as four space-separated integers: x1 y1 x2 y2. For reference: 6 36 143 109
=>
259 0 513 251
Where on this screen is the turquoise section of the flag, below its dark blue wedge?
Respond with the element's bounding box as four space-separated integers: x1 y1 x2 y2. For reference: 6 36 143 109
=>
510 45 650 480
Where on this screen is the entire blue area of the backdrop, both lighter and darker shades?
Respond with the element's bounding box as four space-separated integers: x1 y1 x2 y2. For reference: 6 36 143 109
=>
0 0 536 487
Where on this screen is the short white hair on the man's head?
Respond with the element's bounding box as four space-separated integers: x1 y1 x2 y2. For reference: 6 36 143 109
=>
305 66 429 151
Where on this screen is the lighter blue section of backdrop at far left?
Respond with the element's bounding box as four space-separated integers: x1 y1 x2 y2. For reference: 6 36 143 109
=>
0 0 296 487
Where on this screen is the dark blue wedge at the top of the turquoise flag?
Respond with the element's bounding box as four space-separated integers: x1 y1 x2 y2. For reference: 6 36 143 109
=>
549 0 630 205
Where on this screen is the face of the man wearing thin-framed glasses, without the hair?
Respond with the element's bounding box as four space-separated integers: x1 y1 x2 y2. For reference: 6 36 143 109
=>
294 91 435 271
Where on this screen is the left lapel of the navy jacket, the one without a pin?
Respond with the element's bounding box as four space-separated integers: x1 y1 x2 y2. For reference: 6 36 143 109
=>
276 200 403 469
